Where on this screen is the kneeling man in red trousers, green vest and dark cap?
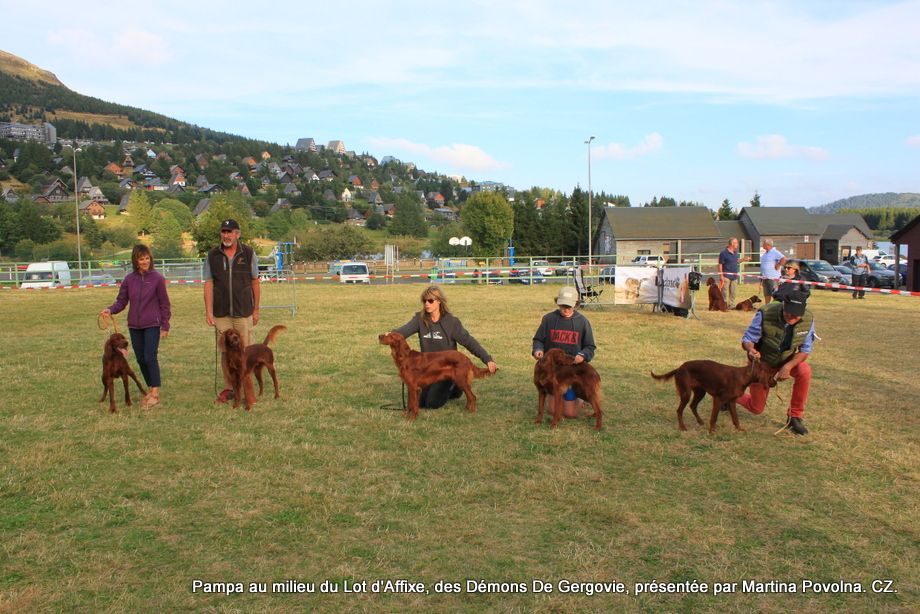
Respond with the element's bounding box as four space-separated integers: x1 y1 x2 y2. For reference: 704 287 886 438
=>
737 291 815 435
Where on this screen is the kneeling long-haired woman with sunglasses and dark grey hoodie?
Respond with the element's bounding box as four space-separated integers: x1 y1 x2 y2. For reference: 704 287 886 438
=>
393 286 498 409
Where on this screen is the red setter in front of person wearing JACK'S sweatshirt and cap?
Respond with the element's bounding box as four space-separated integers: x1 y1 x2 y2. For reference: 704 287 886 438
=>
533 348 604 430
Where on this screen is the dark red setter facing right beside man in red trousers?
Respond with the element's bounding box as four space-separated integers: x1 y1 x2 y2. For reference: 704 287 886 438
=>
652 360 777 433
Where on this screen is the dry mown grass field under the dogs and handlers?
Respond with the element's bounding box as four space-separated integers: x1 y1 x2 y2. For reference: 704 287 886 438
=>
0 284 920 612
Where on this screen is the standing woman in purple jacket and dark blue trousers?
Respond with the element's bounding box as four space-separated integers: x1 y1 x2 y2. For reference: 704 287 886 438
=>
100 245 171 408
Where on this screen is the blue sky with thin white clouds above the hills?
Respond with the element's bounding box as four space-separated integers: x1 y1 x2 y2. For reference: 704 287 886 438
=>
0 0 920 209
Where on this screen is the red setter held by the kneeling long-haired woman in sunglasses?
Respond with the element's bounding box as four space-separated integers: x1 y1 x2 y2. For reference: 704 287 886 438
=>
377 333 492 420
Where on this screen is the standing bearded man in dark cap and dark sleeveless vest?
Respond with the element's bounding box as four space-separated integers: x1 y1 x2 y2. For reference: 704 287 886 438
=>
204 219 261 402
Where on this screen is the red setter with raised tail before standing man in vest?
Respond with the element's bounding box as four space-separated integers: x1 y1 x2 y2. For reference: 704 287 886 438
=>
218 324 287 411
